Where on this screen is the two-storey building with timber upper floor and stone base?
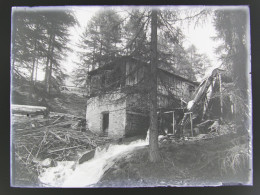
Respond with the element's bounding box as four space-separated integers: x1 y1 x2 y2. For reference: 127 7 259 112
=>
86 57 197 138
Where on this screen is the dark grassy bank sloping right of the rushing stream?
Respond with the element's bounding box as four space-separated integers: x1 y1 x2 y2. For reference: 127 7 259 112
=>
93 134 249 187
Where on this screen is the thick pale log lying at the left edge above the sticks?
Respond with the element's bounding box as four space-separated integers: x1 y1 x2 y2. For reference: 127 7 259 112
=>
11 104 49 116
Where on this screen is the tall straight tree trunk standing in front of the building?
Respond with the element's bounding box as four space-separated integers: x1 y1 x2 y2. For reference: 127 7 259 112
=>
149 9 160 162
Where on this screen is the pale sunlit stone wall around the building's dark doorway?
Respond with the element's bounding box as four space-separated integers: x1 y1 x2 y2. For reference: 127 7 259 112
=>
86 93 126 138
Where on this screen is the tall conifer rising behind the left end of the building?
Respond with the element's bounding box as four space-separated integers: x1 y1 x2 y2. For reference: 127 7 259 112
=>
73 9 122 86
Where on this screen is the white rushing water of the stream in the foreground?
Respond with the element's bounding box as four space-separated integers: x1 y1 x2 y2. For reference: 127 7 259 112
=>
39 140 148 187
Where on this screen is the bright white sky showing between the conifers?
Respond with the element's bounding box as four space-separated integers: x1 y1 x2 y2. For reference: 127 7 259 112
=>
30 6 220 85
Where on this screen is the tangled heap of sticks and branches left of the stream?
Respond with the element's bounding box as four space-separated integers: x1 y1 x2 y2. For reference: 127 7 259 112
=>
12 114 110 183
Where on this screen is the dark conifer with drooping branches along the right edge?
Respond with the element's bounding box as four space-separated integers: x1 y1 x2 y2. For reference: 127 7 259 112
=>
214 9 249 130
